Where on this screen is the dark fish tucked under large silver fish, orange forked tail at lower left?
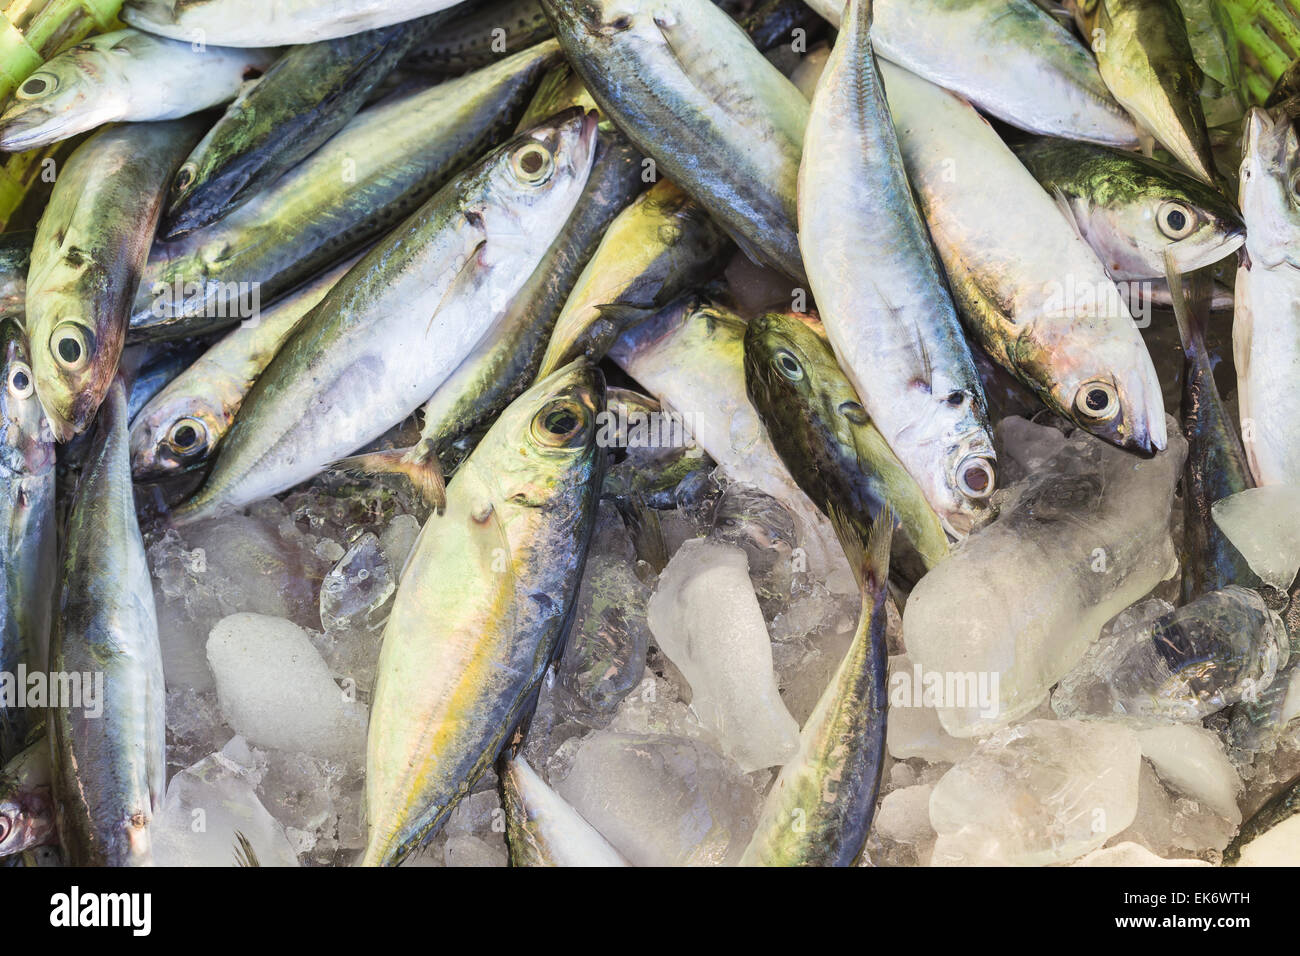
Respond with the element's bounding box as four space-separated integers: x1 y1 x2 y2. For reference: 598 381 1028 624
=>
343 65 642 506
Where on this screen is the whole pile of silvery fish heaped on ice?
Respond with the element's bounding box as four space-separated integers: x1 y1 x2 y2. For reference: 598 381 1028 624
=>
0 0 1300 866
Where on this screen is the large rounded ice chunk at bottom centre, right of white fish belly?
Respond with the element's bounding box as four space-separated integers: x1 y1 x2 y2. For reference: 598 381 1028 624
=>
551 731 759 866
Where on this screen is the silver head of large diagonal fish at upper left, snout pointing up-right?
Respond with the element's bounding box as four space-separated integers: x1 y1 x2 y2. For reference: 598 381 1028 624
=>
465 108 598 248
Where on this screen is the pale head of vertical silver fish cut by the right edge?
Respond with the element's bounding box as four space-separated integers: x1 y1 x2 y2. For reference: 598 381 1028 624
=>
1238 107 1300 267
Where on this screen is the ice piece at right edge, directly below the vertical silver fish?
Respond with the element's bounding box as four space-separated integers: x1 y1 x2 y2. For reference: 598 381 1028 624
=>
1210 485 1300 591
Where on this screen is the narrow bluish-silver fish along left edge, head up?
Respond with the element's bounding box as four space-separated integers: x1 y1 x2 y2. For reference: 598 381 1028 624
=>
0 321 56 760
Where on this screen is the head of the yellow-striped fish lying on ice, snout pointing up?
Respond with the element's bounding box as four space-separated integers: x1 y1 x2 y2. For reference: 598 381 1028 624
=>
468 359 610 509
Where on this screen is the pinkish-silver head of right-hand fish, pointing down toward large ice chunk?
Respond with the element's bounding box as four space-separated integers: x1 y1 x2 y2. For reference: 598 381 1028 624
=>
1011 310 1167 455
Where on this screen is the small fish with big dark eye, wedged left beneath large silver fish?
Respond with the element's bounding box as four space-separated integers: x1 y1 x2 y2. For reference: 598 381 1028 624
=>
130 259 356 481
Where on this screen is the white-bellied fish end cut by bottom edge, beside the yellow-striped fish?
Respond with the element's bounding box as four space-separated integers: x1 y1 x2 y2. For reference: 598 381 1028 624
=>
499 757 632 866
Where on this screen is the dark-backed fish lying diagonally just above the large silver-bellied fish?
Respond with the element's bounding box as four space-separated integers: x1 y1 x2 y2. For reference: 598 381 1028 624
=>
131 42 559 341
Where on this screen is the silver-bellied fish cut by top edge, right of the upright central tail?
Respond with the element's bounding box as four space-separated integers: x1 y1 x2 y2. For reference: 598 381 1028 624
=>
809 0 1139 147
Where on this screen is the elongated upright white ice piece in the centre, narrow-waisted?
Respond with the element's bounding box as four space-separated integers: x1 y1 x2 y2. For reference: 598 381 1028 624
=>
644 540 800 770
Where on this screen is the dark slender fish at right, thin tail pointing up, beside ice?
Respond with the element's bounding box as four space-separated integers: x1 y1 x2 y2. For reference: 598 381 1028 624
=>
1166 251 1261 605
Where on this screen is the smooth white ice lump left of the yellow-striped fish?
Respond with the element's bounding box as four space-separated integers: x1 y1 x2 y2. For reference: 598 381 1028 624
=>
208 614 365 761
